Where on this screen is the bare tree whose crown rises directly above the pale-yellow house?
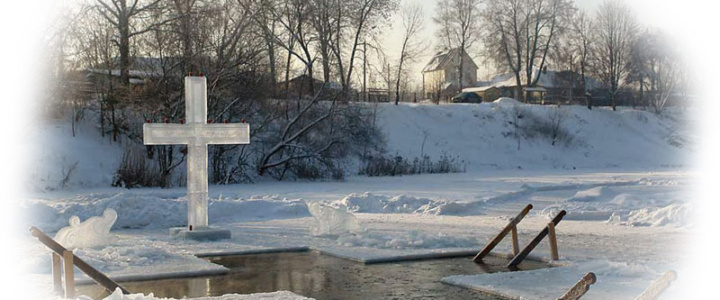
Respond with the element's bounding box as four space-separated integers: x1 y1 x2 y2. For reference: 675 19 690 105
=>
433 0 482 90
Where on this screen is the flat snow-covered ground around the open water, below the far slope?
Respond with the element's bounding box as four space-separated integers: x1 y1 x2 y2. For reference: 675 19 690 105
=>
21 171 692 299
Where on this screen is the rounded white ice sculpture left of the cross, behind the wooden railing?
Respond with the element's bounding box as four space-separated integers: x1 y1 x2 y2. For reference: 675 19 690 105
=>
55 208 117 249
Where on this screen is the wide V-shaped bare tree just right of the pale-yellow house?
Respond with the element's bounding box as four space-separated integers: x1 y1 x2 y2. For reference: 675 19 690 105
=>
483 0 572 102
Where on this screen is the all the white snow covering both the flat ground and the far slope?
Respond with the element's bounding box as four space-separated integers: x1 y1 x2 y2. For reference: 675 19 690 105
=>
19 100 696 299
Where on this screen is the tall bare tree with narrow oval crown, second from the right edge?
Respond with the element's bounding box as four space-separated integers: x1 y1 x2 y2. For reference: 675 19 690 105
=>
592 0 638 110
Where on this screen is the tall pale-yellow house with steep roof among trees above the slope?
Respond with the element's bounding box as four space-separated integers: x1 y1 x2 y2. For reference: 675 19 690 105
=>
422 48 478 100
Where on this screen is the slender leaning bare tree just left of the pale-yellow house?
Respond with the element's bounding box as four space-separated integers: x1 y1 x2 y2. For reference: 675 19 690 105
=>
395 4 424 105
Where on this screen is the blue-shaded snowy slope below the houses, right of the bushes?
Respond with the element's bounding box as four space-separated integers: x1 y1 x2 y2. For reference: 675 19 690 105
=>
377 102 693 171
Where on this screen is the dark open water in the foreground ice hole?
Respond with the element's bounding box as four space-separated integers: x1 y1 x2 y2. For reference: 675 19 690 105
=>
80 252 547 299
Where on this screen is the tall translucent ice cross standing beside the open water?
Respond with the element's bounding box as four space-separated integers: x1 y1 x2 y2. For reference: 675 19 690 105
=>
143 76 250 230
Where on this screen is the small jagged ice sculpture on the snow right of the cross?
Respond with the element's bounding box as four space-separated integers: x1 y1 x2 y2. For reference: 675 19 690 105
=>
308 202 362 236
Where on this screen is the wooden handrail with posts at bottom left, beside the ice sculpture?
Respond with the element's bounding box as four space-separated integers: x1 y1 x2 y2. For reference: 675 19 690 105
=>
30 226 130 298
